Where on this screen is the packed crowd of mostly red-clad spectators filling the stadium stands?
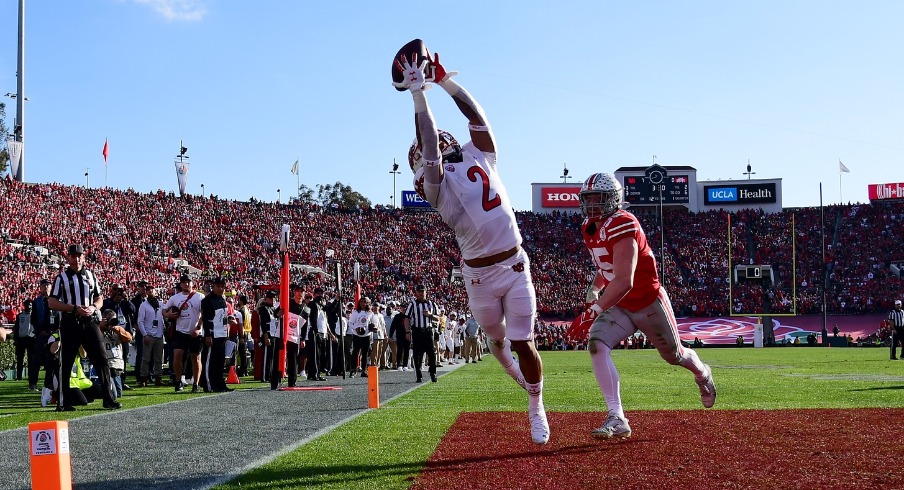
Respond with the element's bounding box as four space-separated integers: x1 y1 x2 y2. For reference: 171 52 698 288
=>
0 181 904 320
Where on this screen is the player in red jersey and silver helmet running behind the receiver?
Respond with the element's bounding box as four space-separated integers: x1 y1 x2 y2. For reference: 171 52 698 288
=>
580 173 716 439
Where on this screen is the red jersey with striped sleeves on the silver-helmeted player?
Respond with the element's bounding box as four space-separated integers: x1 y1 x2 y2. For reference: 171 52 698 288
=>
581 210 659 311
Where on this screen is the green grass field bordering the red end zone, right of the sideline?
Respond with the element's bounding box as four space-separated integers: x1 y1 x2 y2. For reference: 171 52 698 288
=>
217 348 904 489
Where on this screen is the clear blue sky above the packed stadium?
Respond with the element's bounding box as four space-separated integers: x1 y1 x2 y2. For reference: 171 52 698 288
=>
0 0 904 210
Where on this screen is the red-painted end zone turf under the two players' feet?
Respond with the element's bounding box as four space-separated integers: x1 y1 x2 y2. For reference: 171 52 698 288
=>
411 409 904 490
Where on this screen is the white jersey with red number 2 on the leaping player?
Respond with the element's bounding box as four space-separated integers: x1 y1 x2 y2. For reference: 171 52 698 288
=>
431 141 521 259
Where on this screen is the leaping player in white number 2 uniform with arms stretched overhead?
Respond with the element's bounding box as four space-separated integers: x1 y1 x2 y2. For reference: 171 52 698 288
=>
394 49 549 444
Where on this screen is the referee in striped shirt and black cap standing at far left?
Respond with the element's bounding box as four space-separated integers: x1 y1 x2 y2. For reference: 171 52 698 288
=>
47 244 122 412
